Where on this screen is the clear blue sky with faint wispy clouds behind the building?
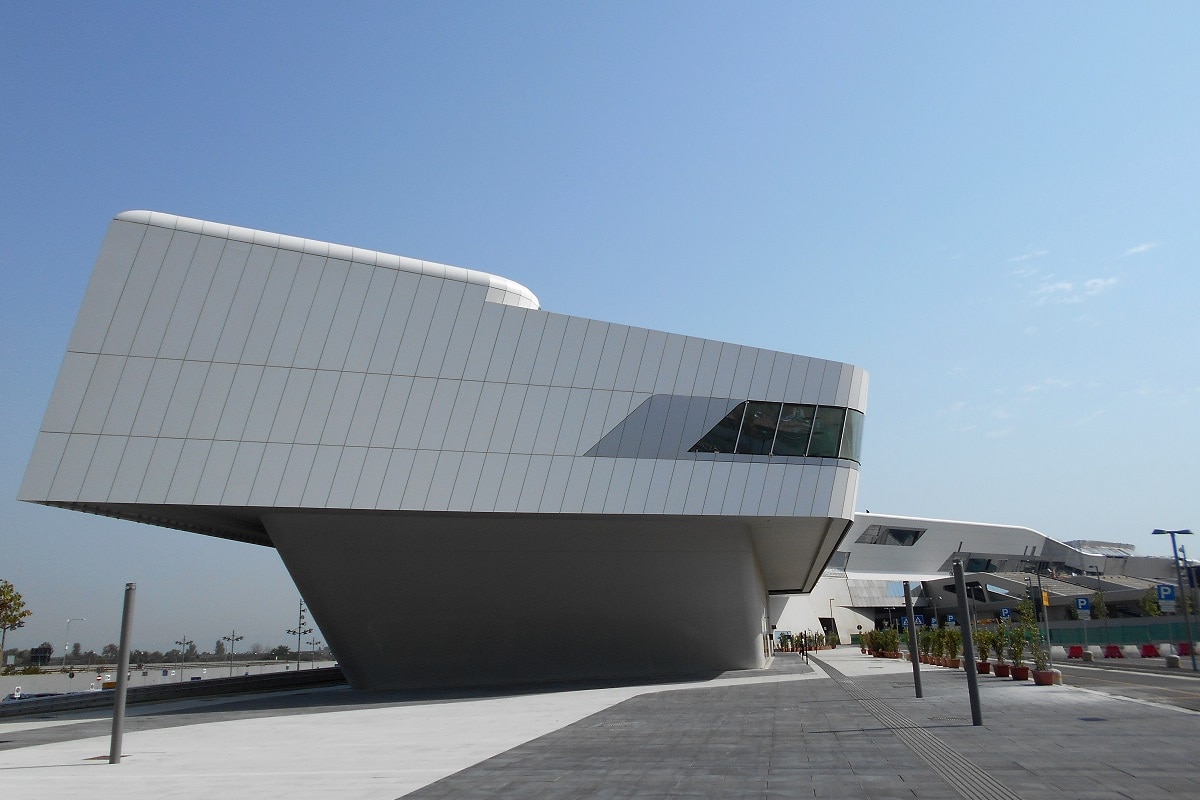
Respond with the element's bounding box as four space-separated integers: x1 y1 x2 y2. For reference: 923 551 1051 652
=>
0 2 1200 650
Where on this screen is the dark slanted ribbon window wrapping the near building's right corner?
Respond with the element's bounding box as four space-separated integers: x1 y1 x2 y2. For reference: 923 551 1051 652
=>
688 401 863 461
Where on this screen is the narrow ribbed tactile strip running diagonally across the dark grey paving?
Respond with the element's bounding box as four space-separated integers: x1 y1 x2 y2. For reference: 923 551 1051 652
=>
809 656 1021 800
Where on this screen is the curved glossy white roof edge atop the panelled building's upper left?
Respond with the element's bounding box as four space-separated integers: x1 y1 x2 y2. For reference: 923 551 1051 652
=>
113 210 541 308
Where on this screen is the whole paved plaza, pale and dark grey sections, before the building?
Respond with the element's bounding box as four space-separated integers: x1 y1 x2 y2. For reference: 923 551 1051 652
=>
0 648 1200 800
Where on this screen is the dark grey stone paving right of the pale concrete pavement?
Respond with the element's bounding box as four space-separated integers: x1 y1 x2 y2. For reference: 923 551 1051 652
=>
404 654 1200 800
